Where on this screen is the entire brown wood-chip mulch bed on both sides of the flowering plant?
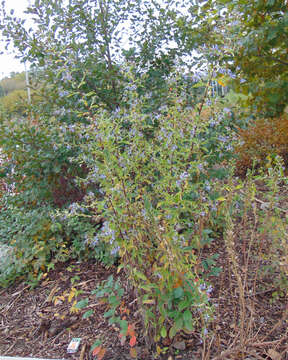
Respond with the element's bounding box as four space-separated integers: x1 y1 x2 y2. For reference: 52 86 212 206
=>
0 233 288 360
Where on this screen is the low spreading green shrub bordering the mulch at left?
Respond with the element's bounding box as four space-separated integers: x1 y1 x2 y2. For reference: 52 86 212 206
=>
0 201 111 286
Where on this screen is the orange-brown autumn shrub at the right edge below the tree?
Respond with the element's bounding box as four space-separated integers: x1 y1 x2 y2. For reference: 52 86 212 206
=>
235 114 288 176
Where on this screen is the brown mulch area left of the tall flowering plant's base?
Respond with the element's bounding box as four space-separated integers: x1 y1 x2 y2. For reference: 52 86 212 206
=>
0 261 202 360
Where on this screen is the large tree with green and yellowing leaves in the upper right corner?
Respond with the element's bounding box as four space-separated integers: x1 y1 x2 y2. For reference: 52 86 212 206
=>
210 0 288 117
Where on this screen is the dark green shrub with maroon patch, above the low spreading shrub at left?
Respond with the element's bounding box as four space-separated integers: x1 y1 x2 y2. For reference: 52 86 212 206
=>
0 114 90 207
